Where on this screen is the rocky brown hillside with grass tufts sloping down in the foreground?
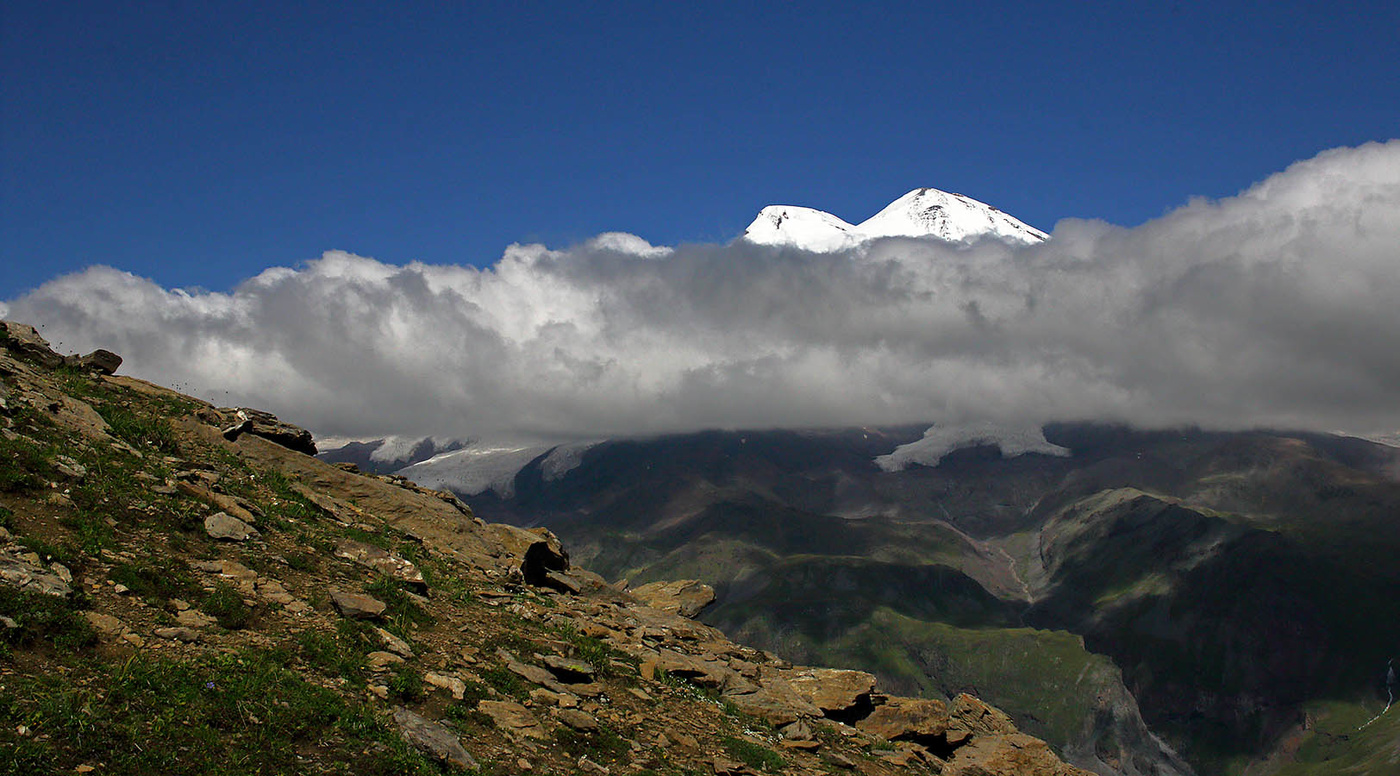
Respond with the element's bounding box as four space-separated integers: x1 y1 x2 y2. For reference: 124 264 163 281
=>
0 315 1084 776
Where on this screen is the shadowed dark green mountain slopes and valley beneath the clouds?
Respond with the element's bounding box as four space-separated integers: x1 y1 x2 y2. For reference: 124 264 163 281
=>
333 424 1400 776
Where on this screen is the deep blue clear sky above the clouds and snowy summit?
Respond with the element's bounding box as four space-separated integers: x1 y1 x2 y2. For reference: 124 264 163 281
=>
0 0 1400 298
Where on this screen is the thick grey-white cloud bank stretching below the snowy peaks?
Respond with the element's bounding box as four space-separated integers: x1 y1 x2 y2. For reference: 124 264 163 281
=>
8 141 1400 440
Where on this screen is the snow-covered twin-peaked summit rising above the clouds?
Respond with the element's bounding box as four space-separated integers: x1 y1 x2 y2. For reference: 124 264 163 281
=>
741 188 1050 254
